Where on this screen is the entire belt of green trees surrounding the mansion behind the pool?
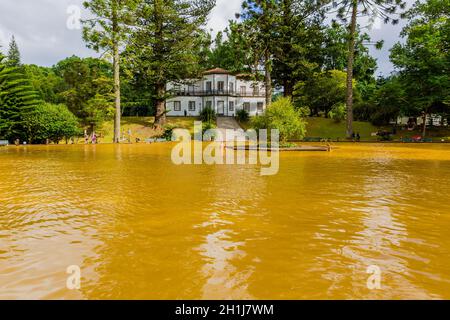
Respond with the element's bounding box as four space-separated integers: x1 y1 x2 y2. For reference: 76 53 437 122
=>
0 0 450 142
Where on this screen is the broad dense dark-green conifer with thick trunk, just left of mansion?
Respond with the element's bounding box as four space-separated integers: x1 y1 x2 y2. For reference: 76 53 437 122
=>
127 0 215 127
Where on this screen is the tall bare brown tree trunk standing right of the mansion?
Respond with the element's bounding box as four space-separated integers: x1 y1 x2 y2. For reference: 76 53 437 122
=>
347 0 358 138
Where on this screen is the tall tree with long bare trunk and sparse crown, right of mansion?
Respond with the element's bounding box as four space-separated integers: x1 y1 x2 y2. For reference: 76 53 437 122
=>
331 0 405 137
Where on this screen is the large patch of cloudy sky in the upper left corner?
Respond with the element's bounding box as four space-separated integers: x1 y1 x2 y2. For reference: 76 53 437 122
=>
0 0 96 66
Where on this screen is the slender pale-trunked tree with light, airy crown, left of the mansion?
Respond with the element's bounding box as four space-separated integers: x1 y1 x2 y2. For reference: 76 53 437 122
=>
83 0 138 143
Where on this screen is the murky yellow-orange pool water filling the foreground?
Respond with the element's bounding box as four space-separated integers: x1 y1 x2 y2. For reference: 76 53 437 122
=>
0 144 450 299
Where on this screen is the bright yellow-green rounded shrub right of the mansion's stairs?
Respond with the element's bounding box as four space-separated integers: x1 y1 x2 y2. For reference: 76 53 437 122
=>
252 97 306 144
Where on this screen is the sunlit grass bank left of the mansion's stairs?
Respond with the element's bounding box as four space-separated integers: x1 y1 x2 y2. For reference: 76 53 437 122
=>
98 117 197 143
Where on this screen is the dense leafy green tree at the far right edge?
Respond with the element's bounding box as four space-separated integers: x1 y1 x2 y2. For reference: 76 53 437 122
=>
391 0 450 131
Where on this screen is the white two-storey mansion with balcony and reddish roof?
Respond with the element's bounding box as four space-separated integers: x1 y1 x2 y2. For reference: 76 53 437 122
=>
166 68 266 117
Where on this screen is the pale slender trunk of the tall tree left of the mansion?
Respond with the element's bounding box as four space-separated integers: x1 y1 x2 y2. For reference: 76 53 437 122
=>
113 9 122 143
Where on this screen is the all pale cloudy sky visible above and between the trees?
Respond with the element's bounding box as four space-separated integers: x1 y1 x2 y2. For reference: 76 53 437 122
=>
0 0 411 75
